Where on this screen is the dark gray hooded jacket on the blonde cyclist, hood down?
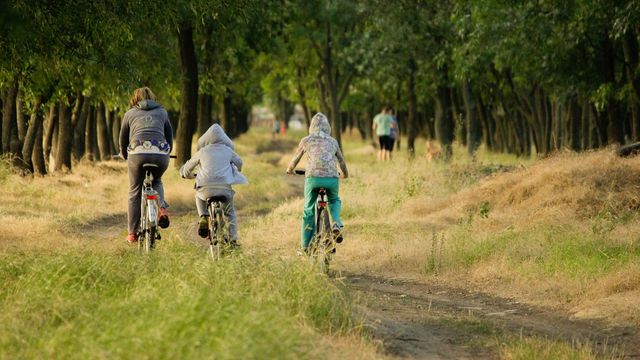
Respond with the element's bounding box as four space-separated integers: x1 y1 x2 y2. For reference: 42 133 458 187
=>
120 100 173 159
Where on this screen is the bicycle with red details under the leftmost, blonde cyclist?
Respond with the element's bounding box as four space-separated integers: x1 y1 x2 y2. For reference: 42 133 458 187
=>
137 164 161 254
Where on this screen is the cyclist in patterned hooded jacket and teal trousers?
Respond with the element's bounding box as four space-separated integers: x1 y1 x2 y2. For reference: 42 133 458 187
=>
287 113 349 253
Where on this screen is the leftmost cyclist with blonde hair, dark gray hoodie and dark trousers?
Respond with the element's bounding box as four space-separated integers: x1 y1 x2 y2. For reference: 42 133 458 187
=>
120 87 173 244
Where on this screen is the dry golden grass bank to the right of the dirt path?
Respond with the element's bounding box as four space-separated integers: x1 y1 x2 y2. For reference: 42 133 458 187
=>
314 146 640 324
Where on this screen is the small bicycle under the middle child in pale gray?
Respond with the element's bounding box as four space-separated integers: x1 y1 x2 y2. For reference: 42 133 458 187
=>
207 196 238 261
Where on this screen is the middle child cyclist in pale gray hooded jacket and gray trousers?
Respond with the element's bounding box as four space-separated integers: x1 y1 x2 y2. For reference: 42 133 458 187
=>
180 124 248 243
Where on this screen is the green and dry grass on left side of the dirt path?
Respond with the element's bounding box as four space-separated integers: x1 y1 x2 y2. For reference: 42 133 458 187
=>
0 131 379 359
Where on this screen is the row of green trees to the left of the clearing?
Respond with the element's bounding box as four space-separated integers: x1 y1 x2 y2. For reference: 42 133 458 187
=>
0 0 273 173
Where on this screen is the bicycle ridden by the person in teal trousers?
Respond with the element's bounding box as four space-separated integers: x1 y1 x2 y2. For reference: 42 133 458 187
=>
294 170 336 274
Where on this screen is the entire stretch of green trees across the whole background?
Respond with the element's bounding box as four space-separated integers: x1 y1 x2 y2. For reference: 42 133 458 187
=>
0 0 640 173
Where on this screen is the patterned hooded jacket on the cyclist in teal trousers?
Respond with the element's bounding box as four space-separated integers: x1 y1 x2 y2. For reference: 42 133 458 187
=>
287 113 349 178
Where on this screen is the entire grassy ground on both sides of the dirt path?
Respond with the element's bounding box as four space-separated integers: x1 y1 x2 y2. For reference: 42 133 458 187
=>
0 127 640 359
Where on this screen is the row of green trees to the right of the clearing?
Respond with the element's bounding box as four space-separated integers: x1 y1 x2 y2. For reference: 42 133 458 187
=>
265 0 640 156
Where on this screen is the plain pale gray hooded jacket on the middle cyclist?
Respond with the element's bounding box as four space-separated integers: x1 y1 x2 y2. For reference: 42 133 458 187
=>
180 124 248 188
